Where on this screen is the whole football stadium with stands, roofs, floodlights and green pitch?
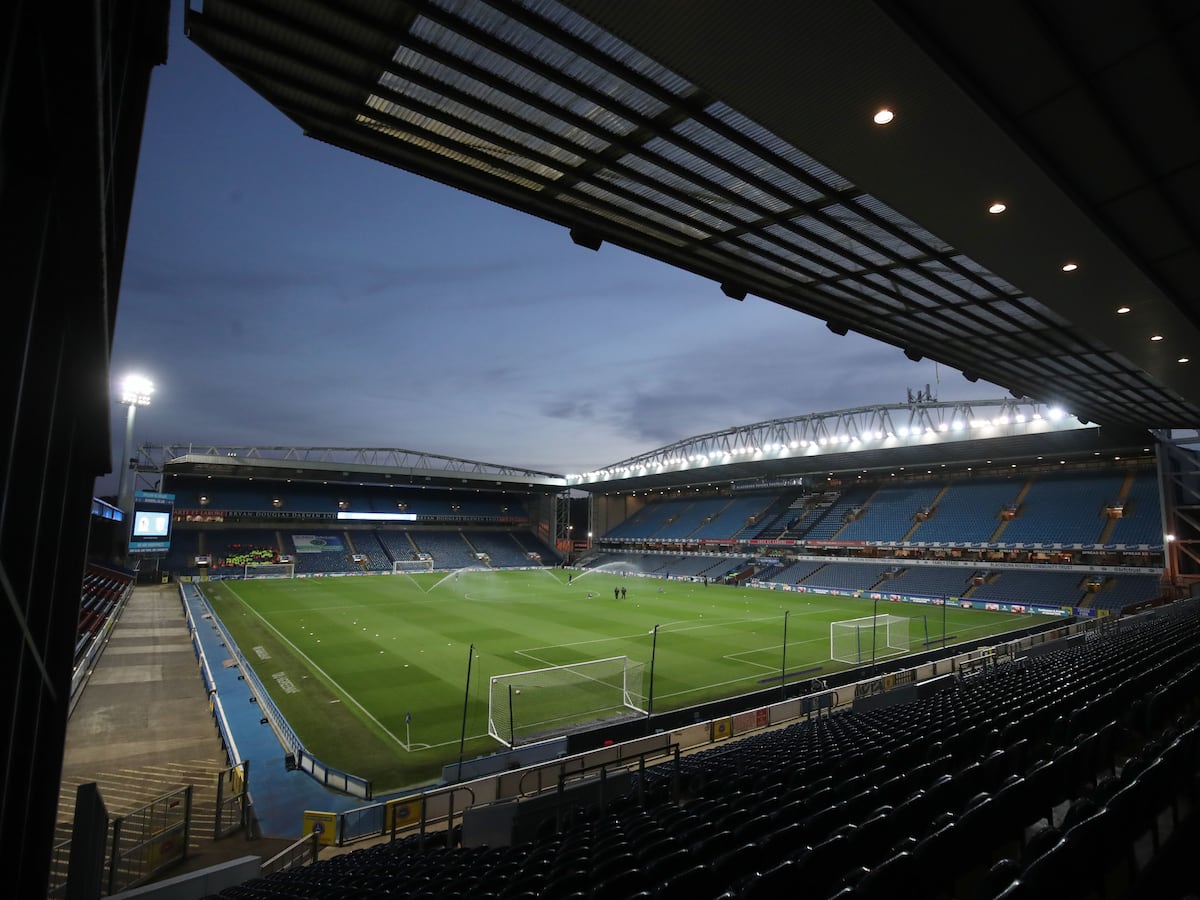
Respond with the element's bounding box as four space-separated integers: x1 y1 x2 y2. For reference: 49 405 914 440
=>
9 0 1200 900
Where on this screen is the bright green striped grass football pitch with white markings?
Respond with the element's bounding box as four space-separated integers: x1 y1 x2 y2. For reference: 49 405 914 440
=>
204 569 1060 793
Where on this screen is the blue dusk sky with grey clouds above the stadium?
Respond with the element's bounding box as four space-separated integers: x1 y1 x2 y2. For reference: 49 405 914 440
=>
105 26 1003 493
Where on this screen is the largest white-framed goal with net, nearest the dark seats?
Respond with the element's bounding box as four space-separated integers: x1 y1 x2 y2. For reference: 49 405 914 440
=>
487 656 646 746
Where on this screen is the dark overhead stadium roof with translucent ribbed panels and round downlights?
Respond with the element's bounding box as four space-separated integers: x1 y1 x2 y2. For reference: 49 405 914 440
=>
186 0 1200 428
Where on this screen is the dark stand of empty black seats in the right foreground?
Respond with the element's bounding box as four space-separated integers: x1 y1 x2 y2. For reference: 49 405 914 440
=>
201 602 1200 900
